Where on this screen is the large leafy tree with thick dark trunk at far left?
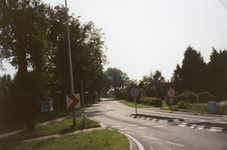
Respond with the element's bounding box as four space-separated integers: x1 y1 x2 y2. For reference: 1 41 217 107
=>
0 0 49 131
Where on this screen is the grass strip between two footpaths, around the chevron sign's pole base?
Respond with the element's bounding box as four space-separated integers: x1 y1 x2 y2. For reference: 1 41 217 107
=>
0 115 100 143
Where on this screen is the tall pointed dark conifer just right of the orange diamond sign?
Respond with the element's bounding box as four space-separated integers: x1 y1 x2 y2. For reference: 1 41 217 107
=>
181 46 206 93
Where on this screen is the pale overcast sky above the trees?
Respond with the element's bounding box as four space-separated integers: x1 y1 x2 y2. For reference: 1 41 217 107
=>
0 0 227 81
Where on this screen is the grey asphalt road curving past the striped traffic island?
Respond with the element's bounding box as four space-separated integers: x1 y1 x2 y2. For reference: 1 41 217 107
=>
85 99 227 150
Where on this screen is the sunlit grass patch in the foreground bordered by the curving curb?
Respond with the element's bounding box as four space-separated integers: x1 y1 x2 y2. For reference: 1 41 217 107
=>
8 129 129 150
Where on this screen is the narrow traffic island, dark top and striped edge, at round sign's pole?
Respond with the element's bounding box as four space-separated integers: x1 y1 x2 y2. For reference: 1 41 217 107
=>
127 114 189 122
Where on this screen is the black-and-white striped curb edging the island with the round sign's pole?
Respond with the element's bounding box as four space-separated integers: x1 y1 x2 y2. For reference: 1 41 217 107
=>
127 115 189 123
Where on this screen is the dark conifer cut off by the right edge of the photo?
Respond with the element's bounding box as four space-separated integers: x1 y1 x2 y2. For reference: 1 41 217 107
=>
207 48 227 96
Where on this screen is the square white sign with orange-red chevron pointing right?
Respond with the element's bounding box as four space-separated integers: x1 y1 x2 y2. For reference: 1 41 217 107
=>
66 94 80 108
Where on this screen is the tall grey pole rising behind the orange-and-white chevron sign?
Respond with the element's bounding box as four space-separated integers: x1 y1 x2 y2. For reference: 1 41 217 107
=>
65 0 76 126
